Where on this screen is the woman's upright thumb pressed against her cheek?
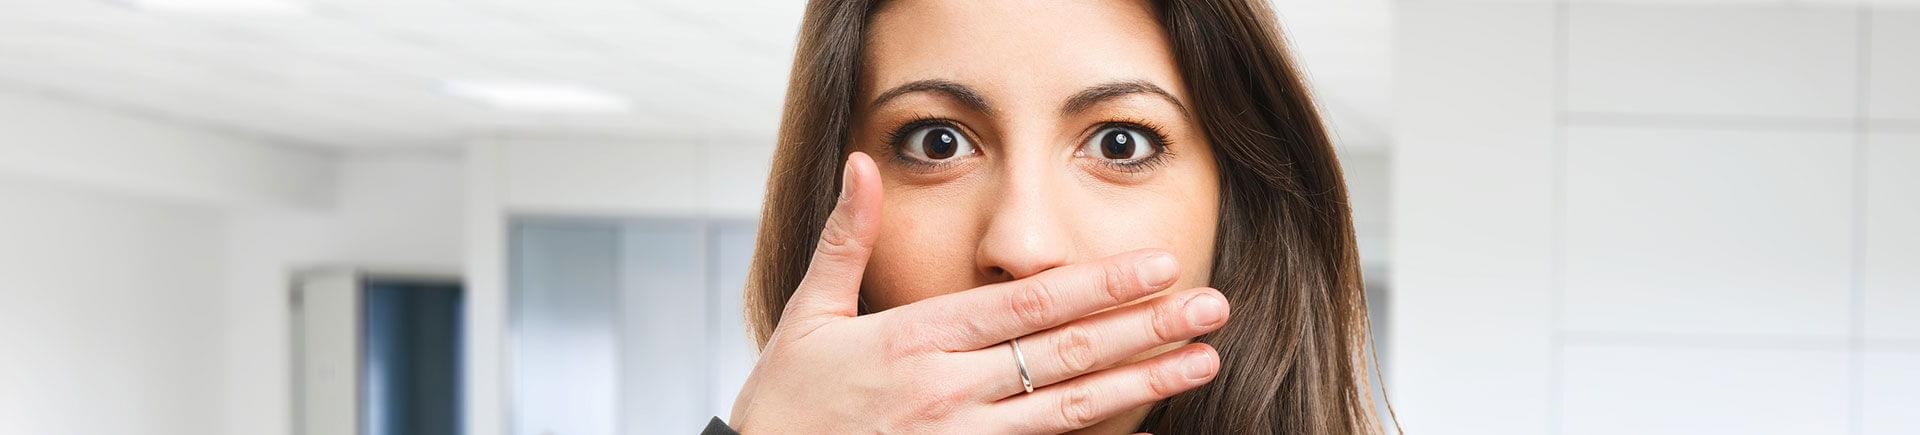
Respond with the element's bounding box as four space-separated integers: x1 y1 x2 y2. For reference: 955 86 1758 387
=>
781 151 881 322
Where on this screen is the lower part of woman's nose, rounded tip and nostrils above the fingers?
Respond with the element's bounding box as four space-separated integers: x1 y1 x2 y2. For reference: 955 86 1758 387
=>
973 164 1073 282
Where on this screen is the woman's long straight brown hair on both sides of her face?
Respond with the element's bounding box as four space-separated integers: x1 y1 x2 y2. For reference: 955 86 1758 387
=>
745 0 1382 433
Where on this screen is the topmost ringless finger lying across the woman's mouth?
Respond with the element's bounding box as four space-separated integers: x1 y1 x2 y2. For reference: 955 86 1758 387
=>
900 249 1179 353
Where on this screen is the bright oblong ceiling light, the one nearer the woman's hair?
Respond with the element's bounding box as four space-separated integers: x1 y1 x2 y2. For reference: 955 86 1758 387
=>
445 80 630 111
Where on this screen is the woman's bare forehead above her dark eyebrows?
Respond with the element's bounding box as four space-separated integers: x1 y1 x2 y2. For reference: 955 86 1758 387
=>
860 0 1185 100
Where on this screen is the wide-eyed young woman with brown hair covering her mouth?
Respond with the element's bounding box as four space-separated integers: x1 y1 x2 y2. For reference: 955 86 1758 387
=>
710 0 1382 433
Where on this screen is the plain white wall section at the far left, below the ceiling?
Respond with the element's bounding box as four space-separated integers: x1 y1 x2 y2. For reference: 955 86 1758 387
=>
0 174 227 435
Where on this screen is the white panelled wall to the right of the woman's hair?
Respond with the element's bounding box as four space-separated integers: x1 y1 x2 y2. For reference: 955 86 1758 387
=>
1386 2 1920 435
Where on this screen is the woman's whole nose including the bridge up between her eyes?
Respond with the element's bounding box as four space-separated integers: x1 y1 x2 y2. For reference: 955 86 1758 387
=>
975 144 1073 280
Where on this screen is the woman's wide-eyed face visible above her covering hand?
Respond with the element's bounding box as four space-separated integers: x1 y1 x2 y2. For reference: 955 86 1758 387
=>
852 0 1219 310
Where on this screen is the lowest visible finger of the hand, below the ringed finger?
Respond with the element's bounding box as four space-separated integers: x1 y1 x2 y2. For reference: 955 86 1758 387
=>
989 343 1219 433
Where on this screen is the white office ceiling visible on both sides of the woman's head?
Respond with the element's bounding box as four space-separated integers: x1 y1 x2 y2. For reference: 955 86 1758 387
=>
0 0 1392 149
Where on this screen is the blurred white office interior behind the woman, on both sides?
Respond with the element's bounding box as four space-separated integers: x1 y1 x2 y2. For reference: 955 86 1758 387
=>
0 0 1920 435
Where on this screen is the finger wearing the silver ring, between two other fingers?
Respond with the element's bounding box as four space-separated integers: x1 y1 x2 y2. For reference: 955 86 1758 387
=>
968 287 1227 401
